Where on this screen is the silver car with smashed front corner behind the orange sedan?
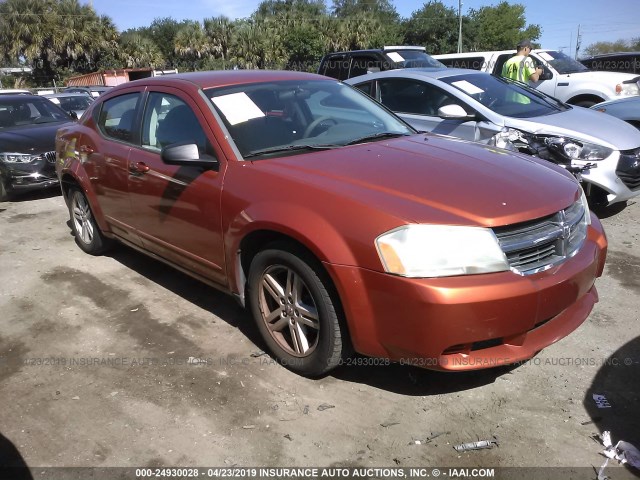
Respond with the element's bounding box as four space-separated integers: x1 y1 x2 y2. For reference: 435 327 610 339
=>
346 68 640 206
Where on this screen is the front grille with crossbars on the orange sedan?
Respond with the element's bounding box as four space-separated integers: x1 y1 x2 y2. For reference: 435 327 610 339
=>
493 201 587 275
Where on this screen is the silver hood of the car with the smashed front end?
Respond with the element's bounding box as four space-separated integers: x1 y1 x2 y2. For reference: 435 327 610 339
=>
504 107 640 150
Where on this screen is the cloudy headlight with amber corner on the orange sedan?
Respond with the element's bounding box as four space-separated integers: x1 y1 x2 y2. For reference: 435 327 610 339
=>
375 224 509 278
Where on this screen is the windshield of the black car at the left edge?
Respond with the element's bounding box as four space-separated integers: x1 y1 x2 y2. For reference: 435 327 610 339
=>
0 95 69 129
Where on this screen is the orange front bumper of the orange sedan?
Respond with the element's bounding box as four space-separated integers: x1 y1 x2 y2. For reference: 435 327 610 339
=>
327 216 607 370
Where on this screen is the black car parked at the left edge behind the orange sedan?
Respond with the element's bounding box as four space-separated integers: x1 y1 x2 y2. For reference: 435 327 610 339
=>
0 95 70 201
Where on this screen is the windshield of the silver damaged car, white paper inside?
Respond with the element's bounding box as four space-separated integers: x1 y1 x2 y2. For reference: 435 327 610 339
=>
441 73 569 118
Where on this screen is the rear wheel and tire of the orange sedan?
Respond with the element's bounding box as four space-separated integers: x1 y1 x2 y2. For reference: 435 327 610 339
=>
69 187 110 255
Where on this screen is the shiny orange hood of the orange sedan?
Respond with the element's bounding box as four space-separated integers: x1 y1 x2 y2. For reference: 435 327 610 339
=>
256 135 579 227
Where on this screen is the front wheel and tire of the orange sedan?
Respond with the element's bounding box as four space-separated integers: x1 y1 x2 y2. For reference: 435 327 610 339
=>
248 248 348 377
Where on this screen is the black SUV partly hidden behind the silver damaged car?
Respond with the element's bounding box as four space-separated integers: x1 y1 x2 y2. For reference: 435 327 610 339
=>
318 46 444 80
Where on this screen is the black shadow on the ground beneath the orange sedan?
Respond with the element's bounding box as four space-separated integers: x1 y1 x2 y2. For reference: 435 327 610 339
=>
90 239 516 396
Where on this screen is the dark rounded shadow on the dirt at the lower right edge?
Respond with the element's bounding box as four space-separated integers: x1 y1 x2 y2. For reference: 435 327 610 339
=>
583 337 640 478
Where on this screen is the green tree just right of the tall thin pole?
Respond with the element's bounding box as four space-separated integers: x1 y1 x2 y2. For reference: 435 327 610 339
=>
469 1 541 51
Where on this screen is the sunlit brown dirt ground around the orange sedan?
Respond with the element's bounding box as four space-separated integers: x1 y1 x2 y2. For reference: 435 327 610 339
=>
0 192 640 479
